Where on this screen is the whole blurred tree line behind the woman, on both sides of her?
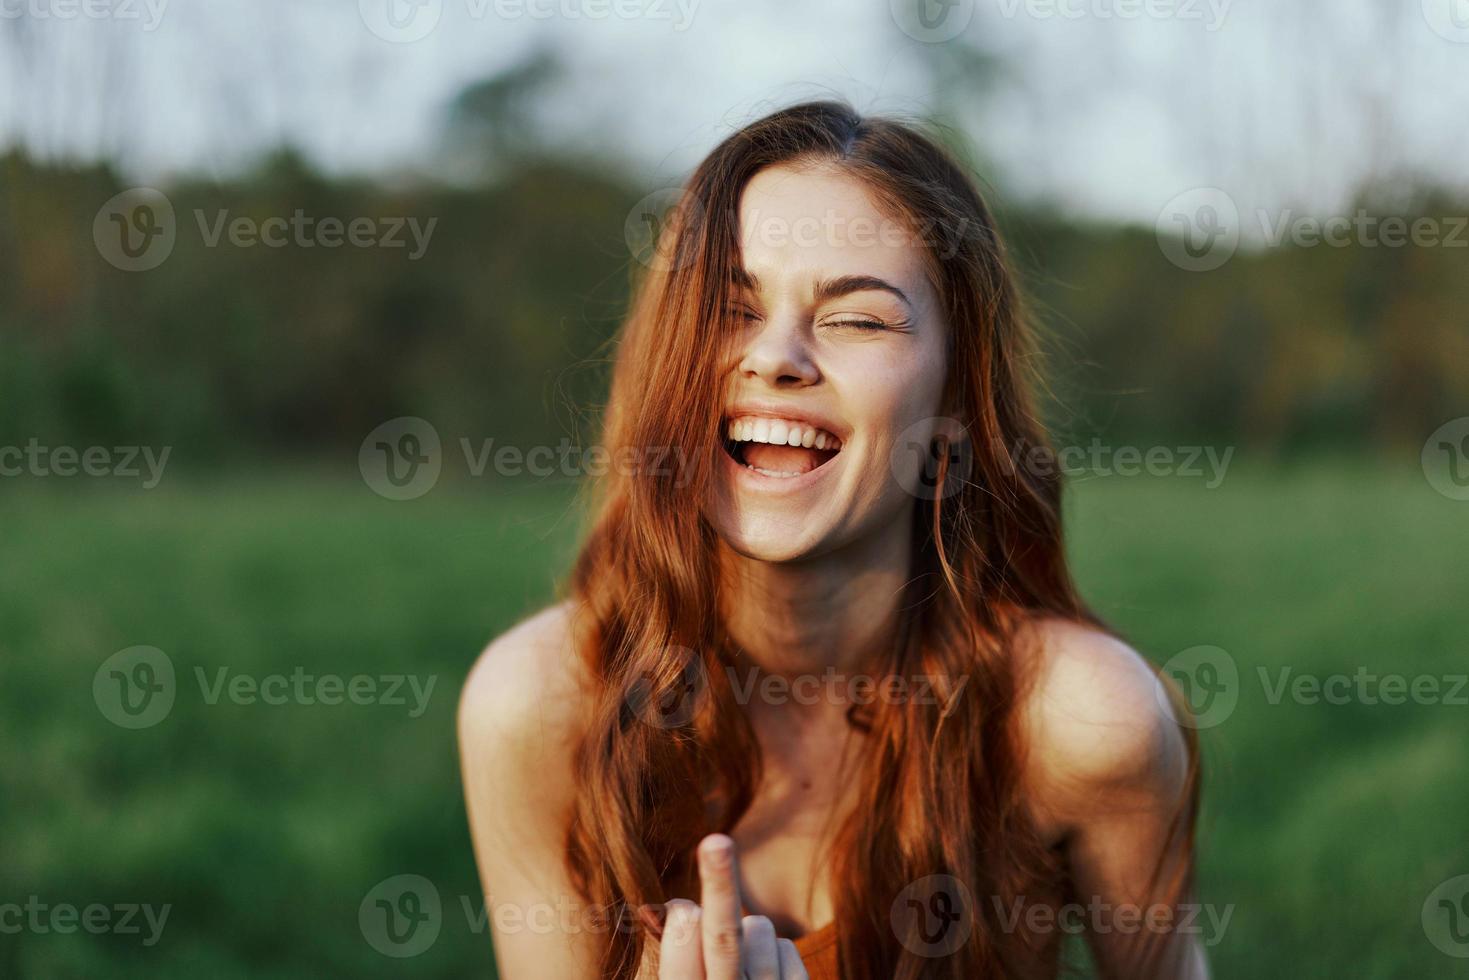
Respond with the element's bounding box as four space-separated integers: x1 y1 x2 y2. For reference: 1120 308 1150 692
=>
0 121 1469 461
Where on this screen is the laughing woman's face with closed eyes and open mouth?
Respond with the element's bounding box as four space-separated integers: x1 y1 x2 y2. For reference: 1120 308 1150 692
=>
710 166 946 561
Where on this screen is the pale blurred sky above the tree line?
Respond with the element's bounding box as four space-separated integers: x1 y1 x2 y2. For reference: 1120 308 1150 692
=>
0 0 1469 223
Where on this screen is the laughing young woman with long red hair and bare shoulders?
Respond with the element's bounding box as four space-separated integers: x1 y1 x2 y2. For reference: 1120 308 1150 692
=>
460 103 1206 980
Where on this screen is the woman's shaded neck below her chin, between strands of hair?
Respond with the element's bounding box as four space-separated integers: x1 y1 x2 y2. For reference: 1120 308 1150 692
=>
720 511 912 702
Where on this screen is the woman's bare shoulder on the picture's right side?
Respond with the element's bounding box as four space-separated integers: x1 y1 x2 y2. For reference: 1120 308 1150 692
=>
1021 619 1188 826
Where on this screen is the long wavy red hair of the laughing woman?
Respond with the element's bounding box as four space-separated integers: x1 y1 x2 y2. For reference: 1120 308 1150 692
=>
567 101 1197 980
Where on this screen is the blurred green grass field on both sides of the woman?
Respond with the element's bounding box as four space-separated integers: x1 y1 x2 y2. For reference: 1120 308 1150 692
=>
0 455 1469 980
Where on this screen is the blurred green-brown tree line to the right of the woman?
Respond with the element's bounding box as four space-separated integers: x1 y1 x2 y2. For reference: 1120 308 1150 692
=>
1005 192 1469 451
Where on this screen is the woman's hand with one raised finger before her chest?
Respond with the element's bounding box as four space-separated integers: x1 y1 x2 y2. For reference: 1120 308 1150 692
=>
648 833 806 980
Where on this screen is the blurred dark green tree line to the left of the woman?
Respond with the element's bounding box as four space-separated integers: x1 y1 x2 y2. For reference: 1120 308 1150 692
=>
0 146 625 458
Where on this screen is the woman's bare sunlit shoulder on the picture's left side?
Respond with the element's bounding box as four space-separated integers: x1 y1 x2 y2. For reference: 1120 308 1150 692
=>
458 602 589 811
